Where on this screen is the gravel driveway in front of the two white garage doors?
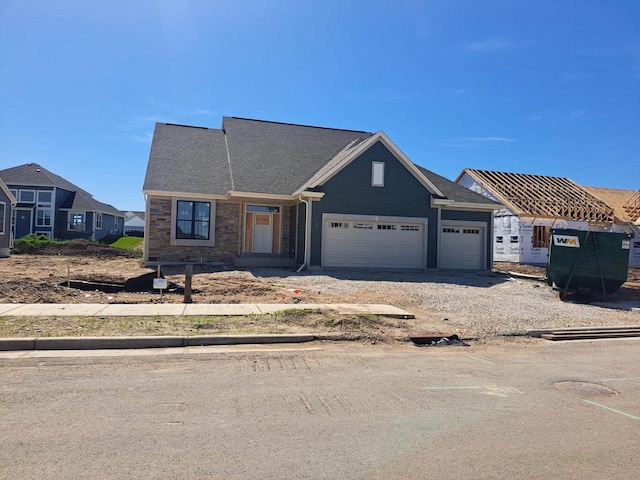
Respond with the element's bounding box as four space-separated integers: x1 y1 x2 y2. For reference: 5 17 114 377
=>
252 269 640 337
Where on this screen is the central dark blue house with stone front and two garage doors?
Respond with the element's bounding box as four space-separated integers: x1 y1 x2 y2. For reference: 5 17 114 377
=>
143 117 501 269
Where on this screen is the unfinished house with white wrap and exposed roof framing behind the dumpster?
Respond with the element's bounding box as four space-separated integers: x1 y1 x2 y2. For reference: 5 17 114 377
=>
456 168 633 264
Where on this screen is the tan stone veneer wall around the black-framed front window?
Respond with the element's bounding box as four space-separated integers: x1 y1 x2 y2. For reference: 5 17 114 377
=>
145 197 241 263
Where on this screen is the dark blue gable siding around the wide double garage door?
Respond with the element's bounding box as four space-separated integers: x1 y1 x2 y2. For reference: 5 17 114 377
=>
311 142 438 268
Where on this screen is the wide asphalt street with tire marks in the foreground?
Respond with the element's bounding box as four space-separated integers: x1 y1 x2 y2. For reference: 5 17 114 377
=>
0 339 640 479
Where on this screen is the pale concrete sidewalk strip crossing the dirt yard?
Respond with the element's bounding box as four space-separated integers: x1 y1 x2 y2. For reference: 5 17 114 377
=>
0 303 415 318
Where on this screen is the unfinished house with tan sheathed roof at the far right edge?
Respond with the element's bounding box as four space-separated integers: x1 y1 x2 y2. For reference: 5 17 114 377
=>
584 187 640 267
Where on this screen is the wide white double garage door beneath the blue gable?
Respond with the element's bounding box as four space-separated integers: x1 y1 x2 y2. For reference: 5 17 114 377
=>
322 220 425 268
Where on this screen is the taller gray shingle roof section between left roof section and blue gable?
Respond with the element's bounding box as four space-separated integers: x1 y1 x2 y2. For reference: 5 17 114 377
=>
222 117 373 195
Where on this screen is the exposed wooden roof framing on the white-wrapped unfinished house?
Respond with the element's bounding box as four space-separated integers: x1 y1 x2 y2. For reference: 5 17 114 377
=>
467 169 616 223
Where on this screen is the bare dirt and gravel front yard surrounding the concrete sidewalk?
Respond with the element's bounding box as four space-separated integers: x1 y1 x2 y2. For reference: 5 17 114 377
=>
0 247 640 339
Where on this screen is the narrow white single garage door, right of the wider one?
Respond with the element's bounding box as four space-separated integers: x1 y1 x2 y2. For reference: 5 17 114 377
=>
440 226 484 269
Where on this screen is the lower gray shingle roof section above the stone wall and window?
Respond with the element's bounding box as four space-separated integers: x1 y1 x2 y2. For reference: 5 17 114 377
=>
143 123 231 195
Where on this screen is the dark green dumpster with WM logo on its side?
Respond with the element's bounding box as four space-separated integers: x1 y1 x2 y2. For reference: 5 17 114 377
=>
547 228 633 297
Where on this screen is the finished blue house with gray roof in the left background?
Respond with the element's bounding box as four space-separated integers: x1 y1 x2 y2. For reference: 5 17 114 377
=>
0 163 124 240
